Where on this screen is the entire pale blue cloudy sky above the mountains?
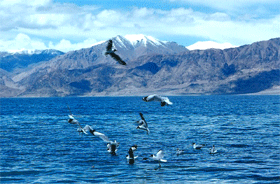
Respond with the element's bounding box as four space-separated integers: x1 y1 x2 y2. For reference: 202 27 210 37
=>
0 0 280 52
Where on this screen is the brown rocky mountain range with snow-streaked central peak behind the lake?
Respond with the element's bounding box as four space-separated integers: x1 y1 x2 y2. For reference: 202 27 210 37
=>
0 35 280 97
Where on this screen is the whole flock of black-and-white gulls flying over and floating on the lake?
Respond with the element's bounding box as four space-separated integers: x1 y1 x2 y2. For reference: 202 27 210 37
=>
68 40 217 167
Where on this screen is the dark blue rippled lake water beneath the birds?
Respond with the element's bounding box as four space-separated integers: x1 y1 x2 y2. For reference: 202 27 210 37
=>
0 96 280 183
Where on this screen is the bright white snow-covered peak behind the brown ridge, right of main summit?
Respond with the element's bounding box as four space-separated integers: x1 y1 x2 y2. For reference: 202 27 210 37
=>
186 41 236 50
